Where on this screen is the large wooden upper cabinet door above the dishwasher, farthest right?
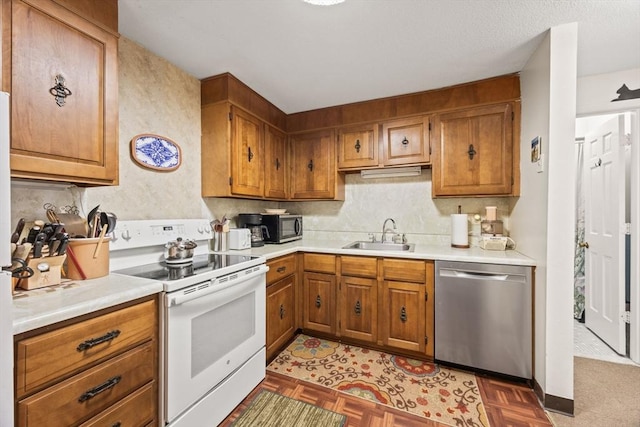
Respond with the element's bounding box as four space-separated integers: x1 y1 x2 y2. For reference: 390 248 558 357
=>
433 104 513 196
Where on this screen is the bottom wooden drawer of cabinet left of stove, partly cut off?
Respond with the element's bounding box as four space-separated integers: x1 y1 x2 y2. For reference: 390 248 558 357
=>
80 382 156 427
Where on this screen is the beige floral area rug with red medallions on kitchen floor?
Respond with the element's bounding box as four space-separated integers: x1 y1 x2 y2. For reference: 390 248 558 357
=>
267 335 489 427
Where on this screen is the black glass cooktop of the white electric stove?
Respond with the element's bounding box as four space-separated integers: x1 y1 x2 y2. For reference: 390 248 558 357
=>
113 254 259 282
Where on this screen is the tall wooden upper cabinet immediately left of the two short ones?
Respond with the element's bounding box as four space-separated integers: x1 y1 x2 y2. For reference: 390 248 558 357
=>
290 129 344 200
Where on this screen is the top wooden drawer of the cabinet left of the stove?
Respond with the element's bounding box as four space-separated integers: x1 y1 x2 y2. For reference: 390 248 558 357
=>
16 299 157 398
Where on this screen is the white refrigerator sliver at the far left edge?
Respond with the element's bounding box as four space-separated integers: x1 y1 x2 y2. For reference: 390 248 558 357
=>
0 92 14 426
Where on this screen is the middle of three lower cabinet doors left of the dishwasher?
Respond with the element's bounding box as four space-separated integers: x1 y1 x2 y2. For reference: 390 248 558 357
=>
340 276 378 342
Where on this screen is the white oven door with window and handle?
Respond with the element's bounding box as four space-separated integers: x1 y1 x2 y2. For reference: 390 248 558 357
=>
165 265 268 422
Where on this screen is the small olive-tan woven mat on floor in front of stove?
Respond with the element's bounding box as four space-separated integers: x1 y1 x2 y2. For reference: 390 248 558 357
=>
232 390 347 427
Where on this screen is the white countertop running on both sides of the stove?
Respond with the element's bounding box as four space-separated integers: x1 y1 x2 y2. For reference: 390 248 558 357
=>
13 239 536 334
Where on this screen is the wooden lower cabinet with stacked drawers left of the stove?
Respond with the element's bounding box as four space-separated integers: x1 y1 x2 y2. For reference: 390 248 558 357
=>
15 297 158 427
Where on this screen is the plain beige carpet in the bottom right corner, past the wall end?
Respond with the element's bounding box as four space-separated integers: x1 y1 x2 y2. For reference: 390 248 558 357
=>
549 357 640 427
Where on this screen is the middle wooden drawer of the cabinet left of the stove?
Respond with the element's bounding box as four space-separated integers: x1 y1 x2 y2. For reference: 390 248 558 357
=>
18 342 156 427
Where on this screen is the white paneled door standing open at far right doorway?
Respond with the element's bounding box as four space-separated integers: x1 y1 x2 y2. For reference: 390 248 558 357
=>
583 114 626 355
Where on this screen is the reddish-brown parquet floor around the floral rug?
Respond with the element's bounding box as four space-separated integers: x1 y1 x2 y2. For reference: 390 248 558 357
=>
221 371 552 427
